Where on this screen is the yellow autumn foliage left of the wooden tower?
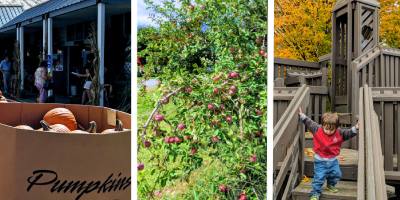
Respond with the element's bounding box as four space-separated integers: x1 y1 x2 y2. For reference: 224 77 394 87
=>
274 0 336 61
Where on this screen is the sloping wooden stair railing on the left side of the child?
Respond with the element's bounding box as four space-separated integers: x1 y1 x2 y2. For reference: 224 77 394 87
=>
273 85 310 199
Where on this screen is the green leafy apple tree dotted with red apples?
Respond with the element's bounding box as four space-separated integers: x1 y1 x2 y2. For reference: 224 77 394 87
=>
138 0 267 199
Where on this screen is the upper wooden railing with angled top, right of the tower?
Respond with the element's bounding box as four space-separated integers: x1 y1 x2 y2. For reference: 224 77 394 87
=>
347 46 400 119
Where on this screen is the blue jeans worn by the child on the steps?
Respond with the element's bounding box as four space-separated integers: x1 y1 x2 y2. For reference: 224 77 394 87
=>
311 159 342 196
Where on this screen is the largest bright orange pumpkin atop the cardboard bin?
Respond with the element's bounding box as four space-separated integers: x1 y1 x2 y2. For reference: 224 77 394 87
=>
43 108 78 131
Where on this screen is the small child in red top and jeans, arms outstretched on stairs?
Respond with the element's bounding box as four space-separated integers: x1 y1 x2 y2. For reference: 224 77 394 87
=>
299 108 358 200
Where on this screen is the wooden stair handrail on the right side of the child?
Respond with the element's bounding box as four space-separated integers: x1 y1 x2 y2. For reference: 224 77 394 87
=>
357 85 387 200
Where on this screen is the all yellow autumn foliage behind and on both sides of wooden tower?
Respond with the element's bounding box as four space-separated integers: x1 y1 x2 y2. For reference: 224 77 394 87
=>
275 0 400 61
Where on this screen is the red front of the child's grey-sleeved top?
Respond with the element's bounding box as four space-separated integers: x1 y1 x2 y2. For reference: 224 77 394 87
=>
313 127 343 158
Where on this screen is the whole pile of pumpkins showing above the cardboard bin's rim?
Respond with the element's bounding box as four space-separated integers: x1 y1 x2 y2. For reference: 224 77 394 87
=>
15 108 127 134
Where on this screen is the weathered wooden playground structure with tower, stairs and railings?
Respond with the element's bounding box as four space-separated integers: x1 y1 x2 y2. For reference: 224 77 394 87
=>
273 0 400 200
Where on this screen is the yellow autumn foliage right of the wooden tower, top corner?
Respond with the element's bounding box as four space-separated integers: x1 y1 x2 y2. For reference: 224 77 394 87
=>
379 0 400 48
